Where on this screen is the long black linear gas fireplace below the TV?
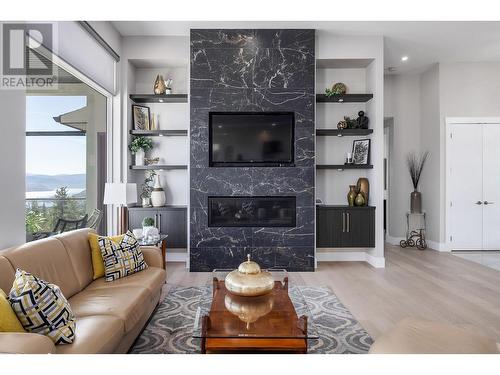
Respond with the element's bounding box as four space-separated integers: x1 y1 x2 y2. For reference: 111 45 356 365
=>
208 196 296 227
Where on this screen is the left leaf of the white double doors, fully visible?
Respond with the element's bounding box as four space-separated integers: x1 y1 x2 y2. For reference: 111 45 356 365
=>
448 124 483 250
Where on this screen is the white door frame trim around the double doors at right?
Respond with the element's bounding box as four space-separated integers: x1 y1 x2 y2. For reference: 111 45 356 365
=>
444 117 500 251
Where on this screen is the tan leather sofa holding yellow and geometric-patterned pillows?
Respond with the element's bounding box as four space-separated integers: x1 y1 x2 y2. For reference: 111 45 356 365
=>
0 229 166 354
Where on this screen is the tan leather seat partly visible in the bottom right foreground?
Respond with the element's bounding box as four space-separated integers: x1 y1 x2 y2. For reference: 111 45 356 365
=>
370 318 500 354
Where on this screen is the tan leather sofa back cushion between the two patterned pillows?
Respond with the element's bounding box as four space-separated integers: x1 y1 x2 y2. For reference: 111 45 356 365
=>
2 238 81 298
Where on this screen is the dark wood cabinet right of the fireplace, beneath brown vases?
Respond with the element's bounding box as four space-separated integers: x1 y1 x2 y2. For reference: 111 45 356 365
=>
316 206 375 247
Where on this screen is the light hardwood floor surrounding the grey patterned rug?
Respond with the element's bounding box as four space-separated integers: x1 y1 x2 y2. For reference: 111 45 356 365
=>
165 245 500 342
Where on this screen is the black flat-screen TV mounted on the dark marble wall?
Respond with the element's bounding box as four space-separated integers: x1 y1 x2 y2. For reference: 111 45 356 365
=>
209 112 295 167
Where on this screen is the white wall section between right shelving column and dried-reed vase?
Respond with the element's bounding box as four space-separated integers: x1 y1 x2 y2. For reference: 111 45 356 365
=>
384 75 425 238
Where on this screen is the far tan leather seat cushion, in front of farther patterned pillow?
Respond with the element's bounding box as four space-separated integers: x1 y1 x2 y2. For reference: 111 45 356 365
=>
69 286 151 332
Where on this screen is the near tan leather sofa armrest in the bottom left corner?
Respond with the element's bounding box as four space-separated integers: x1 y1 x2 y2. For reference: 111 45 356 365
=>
0 332 56 354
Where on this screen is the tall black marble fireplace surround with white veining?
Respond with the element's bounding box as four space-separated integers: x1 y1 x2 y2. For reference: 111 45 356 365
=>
190 29 315 271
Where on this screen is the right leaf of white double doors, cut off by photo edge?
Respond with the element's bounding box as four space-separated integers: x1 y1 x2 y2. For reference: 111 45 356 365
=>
483 124 500 250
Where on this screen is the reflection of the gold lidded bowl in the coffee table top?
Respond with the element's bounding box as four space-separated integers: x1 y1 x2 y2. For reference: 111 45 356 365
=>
224 294 274 328
